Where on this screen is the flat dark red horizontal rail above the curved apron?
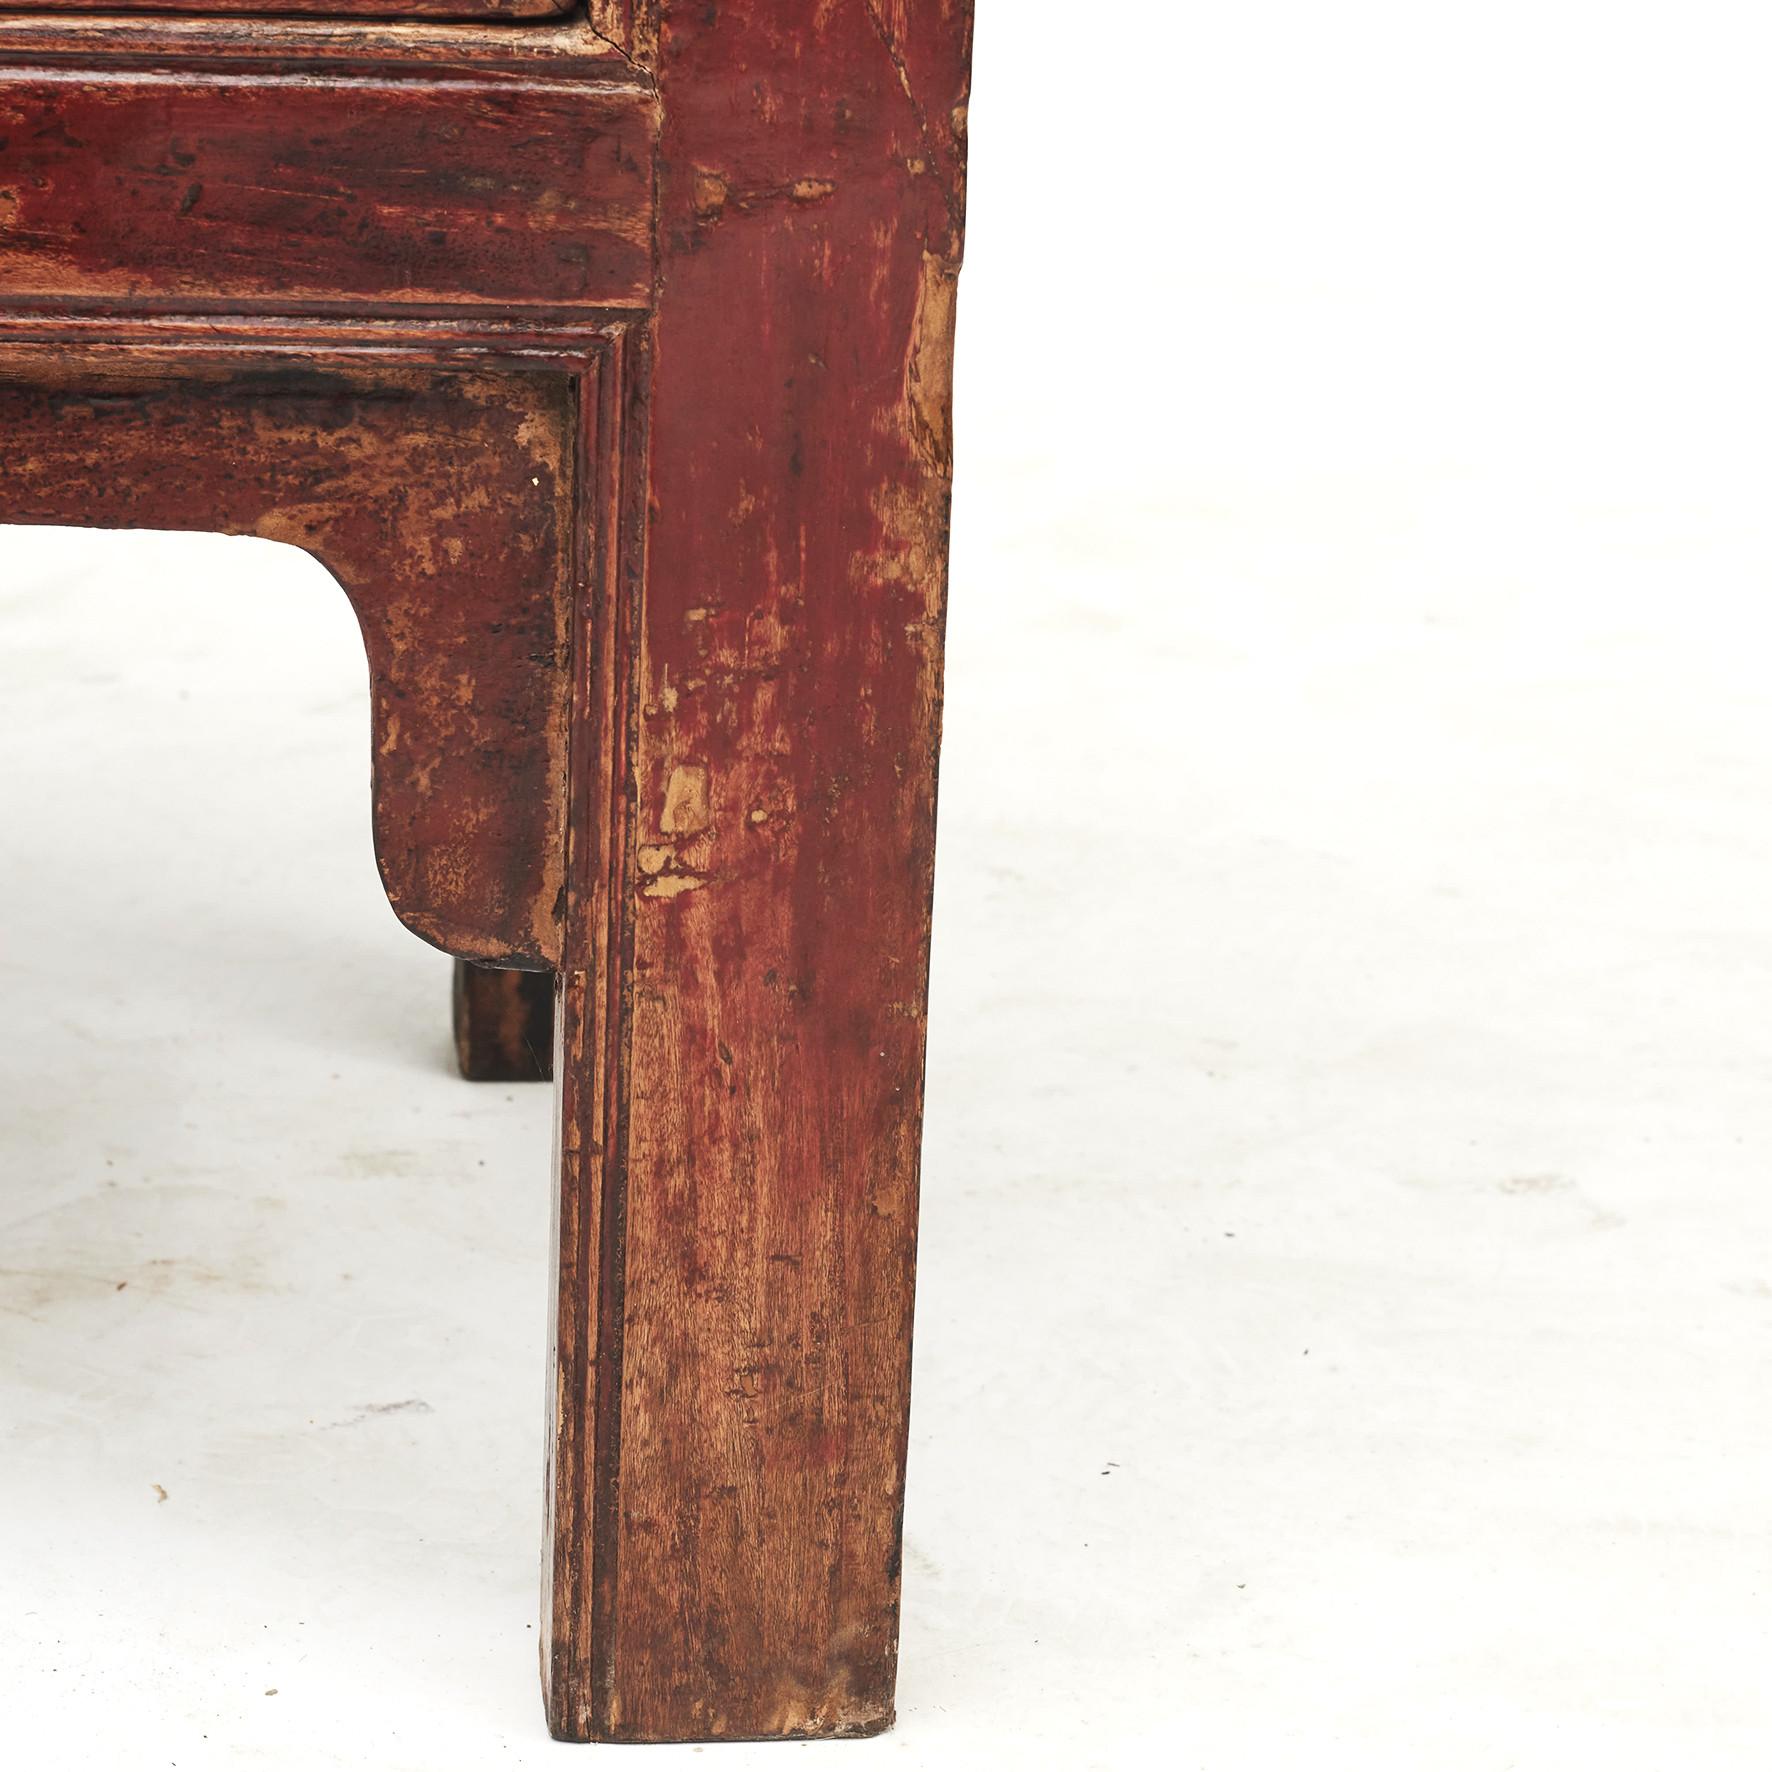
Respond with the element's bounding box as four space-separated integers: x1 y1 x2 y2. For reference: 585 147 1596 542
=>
0 71 656 314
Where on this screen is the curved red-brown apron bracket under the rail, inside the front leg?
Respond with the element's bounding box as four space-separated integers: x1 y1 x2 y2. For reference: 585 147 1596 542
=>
0 361 576 966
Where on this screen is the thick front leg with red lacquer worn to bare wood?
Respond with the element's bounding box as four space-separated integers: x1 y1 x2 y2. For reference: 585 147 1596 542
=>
546 0 969 1740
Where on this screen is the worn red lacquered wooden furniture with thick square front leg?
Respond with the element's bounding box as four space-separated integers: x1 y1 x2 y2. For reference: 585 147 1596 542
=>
0 0 969 1740
